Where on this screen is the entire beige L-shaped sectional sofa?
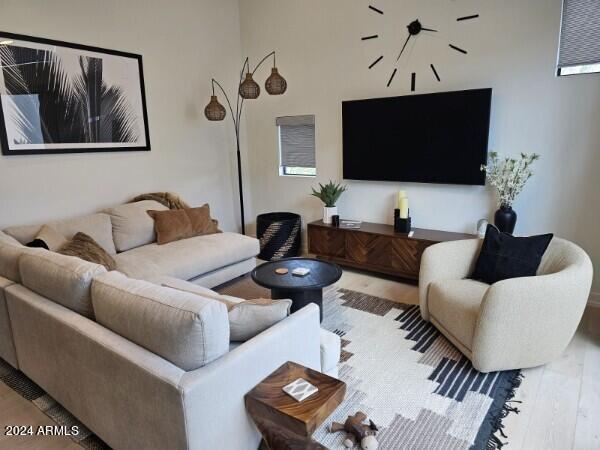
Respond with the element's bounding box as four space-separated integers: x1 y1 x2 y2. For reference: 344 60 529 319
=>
0 203 340 450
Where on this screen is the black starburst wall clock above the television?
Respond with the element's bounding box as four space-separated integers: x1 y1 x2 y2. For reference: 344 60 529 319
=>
361 5 479 92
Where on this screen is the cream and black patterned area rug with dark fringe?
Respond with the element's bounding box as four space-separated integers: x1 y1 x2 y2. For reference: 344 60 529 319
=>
0 286 522 450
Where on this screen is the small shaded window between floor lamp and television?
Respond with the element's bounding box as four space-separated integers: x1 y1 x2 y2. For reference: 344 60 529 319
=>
275 116 317 177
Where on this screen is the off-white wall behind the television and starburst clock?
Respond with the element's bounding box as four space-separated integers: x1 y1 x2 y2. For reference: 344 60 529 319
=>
240 0 600 296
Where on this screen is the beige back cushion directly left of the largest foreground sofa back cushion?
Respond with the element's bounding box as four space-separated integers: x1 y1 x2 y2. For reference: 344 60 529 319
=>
19 250 106 319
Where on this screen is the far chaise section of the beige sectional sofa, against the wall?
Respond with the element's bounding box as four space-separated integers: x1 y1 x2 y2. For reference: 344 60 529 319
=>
4 200 260 287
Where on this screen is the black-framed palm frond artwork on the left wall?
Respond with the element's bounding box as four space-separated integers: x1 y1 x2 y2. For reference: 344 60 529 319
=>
0 32 150 155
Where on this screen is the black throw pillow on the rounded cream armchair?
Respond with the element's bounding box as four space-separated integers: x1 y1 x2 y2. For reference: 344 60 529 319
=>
471 225 553 284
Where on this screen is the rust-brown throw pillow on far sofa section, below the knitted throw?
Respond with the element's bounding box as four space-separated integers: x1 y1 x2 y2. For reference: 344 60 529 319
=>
148 204 221 245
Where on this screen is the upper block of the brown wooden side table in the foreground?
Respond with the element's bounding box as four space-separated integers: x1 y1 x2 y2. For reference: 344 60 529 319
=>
246 362 346 436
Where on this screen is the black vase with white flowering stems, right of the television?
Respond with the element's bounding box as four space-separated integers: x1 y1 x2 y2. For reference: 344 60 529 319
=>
481 152 540 234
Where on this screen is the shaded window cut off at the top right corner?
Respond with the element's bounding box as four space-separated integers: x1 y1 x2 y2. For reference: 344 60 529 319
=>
557 0 600 76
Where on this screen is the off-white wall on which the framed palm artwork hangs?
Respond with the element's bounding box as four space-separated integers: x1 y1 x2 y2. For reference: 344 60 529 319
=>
0 0 241 230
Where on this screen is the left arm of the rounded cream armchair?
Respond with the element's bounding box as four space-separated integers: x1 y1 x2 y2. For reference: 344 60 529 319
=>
419 239 483 320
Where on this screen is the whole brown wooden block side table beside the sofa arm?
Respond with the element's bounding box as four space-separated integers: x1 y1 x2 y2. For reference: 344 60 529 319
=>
245 362 346 450
